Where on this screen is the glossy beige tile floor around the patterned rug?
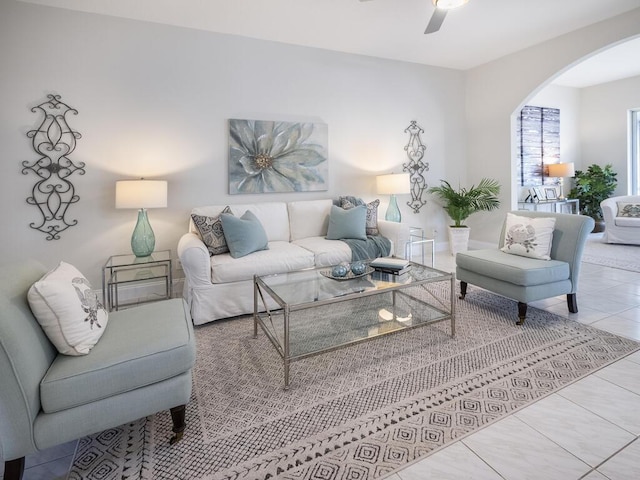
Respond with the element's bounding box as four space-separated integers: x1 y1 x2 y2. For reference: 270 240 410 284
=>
6 252 640 480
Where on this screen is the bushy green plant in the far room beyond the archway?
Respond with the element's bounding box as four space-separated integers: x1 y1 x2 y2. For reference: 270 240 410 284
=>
569 163 618 232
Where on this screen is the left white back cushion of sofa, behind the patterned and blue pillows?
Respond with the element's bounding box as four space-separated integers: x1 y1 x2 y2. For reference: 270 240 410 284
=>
189 202 289 242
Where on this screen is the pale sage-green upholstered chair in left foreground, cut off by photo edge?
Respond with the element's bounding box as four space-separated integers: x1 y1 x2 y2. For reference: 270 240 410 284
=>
0 261 195 480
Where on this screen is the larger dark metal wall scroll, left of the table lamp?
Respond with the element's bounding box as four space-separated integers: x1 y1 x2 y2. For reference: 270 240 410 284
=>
22 95 85 240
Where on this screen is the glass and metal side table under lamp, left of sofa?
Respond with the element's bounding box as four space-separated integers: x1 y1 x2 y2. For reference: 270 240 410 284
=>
102 250 173 311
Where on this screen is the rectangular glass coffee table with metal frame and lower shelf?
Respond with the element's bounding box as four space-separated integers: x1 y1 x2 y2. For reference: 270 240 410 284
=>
253 262 455 389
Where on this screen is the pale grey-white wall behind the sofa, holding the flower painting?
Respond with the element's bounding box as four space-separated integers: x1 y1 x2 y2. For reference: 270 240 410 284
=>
0 0 466 287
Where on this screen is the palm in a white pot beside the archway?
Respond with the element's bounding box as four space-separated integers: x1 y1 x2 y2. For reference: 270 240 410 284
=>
428 178 500 255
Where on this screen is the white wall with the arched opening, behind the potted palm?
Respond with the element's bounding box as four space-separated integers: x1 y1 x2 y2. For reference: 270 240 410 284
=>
466 8 640 243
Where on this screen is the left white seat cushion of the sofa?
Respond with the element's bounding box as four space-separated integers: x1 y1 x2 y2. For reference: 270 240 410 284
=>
211 242 314 283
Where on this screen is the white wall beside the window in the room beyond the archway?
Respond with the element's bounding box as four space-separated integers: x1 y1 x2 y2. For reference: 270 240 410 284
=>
580 77 640 195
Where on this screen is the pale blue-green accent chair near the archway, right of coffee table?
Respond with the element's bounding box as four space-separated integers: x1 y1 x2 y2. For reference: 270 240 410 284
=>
456 210 594 325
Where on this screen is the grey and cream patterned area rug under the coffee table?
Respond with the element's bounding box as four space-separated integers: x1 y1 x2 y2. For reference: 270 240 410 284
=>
69 287 640 480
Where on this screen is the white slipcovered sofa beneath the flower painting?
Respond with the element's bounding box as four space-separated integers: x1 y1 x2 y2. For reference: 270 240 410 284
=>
178 199 409 325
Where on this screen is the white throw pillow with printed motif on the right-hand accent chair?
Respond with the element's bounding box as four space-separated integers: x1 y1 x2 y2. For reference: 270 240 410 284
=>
502 213 556 260
